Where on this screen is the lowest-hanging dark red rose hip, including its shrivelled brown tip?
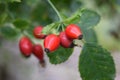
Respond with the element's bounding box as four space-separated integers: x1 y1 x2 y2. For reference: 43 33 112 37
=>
32 44 45 67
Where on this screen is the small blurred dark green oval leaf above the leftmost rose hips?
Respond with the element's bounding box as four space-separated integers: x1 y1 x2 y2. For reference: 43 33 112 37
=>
13 19 29 30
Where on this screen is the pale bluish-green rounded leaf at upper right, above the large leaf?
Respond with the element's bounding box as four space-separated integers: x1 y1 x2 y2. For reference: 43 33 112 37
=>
79 9 100 29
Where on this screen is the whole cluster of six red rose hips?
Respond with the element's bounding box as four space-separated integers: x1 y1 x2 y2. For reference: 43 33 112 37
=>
19 24 83 67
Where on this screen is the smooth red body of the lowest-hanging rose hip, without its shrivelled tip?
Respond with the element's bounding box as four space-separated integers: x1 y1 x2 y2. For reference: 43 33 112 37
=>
32 44 44 61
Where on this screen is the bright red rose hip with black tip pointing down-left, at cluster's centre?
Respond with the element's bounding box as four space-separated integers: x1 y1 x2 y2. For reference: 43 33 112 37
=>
44 34 60 53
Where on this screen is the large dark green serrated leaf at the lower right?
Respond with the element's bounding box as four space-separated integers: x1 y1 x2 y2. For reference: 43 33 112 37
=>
79 43 116 80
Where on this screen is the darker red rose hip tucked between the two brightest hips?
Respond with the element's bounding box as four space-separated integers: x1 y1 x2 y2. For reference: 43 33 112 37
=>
59 31 74 48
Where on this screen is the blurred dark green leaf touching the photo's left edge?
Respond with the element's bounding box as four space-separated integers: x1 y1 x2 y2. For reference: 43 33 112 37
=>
0 26 18 38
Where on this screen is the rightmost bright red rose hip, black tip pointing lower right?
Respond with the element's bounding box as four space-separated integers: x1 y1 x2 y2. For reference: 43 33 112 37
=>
65 24 83 39
